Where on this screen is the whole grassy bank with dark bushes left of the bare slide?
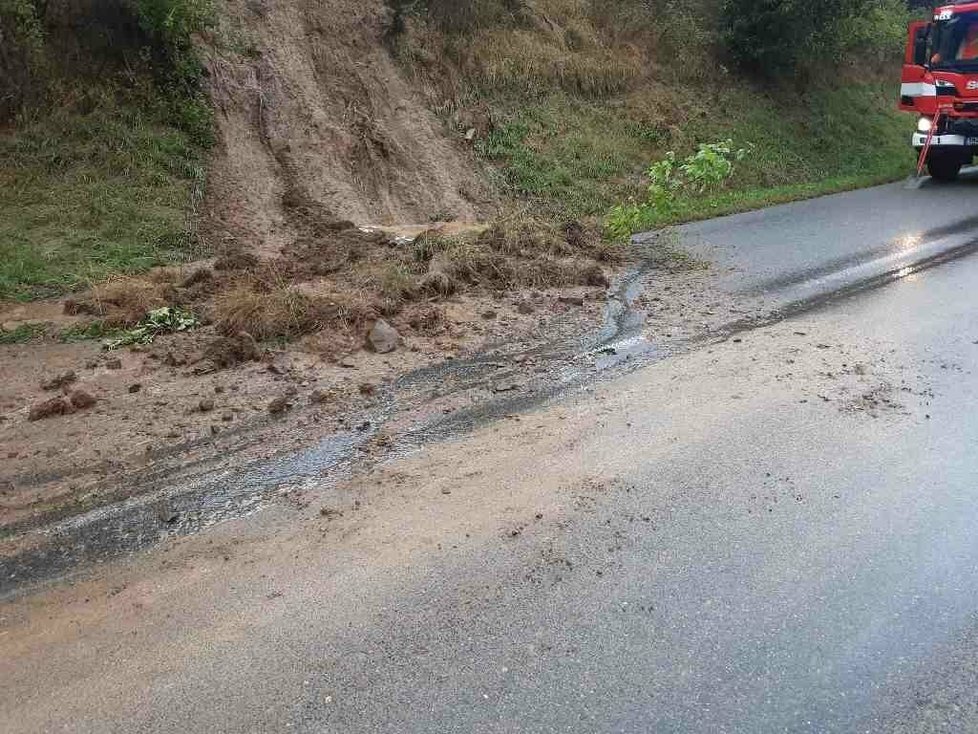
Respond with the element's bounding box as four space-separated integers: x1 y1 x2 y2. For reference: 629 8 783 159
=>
0 0 213 300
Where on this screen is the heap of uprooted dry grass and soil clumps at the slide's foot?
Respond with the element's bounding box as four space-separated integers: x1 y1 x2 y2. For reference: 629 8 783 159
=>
21 207 625 358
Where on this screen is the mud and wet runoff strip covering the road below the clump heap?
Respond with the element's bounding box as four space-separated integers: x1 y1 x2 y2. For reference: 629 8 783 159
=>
0 237 762 593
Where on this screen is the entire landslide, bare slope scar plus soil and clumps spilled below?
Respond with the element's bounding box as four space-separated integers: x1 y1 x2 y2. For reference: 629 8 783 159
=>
0 0 622 551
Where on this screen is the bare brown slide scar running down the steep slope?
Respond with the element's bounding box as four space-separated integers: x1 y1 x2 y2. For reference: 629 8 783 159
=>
206 0 491 252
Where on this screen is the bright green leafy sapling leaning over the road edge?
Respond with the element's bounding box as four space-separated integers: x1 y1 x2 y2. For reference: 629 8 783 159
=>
605 140 751 240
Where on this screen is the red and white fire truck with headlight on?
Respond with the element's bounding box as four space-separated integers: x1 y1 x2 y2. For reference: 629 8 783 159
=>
900 0 978 181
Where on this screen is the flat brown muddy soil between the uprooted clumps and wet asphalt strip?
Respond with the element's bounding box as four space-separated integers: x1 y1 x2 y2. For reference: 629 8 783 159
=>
0 274 604 529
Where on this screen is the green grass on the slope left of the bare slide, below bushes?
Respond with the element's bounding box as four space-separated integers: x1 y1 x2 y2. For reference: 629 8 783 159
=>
0 100 203 300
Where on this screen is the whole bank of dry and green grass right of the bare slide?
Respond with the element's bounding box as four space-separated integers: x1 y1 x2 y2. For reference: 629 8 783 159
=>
397 0 913 233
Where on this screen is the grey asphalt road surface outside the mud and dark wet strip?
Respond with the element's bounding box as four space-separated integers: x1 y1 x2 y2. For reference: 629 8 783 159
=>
0 180 978 732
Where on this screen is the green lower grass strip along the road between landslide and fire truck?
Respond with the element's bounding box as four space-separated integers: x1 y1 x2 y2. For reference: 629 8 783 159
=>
477 80 913 228
